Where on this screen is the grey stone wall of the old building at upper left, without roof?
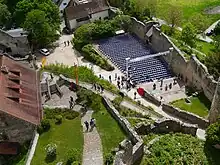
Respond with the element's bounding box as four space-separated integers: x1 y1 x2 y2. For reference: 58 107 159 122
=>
0 30 30 56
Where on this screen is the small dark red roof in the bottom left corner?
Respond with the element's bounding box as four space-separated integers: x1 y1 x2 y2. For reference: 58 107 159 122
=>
0 142 20 155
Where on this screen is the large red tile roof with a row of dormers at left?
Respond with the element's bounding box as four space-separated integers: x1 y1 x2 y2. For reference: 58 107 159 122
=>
0 55 42 125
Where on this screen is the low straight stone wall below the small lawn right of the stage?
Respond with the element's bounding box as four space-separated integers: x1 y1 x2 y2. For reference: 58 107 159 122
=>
162 104 209 129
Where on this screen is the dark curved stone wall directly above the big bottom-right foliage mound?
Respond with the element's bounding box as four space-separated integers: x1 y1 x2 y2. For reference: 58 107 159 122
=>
135 118 198 136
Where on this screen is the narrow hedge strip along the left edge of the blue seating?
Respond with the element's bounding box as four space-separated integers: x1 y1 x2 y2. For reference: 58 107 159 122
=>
82 44 114 71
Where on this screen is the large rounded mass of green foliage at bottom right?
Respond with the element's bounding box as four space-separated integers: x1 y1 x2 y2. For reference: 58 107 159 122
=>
142 133 208 165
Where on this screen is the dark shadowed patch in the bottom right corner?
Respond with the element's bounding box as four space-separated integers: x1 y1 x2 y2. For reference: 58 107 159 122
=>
204 143 220 165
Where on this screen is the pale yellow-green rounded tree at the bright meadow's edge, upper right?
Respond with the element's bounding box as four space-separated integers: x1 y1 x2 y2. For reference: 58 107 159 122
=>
190 13 208 31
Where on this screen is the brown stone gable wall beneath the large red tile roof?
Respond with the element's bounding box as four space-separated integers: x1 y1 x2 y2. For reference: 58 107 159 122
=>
0 112 36 144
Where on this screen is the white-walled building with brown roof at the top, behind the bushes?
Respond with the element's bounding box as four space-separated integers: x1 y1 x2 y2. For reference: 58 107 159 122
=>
64 0 109 30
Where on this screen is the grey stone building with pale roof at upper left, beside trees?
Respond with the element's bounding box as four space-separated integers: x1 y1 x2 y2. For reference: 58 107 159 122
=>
0 29 31 56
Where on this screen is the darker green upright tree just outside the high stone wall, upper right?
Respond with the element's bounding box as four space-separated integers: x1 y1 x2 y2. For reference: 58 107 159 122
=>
181 23 196 48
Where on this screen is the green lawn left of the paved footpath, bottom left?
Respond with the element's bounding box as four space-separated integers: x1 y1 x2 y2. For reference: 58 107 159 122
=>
31 117 83 165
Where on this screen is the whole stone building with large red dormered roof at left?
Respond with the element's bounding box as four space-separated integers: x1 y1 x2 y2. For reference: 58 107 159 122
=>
0 55 42 154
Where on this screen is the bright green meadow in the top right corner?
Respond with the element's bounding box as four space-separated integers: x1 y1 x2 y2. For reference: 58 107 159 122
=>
157 0 220 27
